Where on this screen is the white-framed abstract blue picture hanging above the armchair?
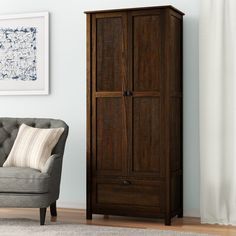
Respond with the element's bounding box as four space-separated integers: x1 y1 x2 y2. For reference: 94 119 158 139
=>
0 12 49 95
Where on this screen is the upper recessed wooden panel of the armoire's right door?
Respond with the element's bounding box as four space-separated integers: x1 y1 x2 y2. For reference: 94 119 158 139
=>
132 14 162 92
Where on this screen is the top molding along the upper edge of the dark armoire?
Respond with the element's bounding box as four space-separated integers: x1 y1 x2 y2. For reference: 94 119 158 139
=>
84 5 184 15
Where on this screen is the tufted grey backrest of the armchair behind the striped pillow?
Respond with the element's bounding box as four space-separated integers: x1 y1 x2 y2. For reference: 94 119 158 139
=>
0 118 68 166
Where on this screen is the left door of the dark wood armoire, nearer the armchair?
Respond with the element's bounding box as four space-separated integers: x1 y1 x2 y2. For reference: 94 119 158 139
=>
92 12 127 176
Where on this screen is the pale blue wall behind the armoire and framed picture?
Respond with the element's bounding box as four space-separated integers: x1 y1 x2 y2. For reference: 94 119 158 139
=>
0 0 199 216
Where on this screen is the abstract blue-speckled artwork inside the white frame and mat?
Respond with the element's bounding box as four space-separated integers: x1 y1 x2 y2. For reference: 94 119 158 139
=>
0 27 37 81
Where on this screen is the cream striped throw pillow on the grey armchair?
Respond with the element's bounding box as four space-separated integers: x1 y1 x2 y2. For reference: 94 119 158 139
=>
3 124 64 171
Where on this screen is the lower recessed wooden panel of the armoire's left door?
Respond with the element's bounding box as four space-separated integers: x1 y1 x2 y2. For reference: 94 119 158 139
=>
93 97 125 175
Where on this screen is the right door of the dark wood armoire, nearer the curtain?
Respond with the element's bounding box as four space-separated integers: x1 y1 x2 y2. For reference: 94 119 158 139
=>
127 10 165 178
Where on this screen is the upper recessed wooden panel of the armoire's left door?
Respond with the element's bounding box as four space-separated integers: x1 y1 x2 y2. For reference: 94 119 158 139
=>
96 16 124 91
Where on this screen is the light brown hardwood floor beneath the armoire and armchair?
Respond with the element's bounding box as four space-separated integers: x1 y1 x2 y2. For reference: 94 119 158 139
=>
0 208 236 236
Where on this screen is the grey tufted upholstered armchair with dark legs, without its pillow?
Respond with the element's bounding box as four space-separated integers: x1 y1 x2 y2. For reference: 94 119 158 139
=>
0 118 69 225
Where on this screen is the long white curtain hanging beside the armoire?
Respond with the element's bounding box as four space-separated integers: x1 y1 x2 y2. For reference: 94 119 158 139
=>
199 0 236 225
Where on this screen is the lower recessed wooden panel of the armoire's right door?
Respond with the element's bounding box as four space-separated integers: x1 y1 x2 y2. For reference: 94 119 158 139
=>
132 97 161 175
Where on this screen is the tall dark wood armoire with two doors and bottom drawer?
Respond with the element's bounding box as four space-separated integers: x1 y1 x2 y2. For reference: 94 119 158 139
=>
86 6 184 225
